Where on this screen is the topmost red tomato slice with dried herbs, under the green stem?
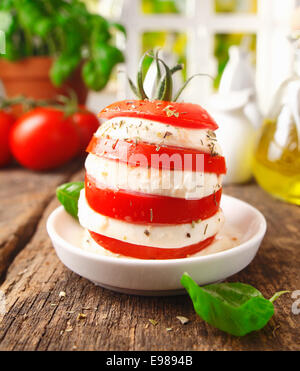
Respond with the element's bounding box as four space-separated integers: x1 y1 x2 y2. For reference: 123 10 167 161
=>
99 100 218 130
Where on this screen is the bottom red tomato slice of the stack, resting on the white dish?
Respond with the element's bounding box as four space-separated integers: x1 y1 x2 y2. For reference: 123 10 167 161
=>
89 231 215 260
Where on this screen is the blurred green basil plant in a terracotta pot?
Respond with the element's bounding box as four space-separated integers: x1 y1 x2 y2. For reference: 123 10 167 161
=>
0 0 125 103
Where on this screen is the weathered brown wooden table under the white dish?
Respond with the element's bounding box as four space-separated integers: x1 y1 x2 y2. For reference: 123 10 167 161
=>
0 163 300 351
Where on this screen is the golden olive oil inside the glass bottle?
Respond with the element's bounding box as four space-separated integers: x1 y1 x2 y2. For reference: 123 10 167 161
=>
253 119 300 205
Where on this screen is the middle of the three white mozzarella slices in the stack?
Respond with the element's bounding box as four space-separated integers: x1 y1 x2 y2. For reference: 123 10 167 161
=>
85 154 222 200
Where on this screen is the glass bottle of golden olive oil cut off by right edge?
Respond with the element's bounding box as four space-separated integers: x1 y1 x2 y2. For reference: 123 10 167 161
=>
253 39 300 205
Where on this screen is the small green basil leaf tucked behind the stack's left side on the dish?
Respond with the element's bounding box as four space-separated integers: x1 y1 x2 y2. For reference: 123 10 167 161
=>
56 182 84 220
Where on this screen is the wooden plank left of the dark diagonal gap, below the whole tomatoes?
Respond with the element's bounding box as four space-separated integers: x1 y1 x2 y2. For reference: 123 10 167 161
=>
0 161 80 277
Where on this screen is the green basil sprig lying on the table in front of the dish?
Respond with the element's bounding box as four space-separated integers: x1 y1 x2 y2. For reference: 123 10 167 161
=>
181 273 287 336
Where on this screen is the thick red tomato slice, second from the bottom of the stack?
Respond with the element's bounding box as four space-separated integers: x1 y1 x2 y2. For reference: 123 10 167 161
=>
85 175 222 225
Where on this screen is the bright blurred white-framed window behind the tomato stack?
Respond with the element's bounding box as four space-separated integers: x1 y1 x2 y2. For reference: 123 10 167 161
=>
88 0 297 112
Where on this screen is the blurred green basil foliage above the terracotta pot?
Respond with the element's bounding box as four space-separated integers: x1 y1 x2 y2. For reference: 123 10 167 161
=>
0 0 126 91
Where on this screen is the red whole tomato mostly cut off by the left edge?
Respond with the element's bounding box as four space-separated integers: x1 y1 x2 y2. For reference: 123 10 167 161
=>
0 111 15 167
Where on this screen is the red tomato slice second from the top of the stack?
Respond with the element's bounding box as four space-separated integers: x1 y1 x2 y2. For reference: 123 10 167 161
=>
87 137 226 174
